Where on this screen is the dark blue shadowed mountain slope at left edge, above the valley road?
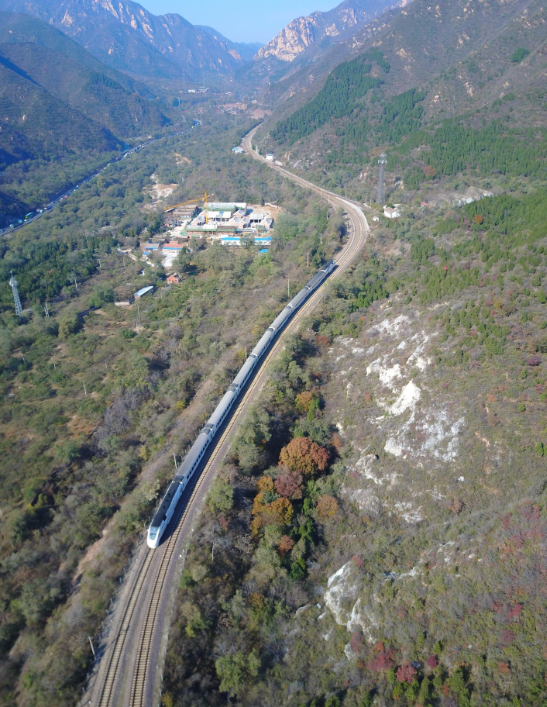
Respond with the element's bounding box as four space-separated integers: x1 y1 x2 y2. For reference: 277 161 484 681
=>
0 12 169 226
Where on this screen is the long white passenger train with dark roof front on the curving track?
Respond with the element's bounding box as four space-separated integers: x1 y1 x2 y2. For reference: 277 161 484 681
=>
147 260 336 548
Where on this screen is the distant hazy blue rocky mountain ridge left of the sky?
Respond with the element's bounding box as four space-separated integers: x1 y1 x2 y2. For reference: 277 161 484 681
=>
0 0 244 81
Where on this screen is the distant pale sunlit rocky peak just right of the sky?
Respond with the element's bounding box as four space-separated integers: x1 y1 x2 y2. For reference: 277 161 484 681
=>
255 0 411 62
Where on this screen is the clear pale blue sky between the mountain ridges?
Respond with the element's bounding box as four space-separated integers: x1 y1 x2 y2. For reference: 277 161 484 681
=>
137 0 341 44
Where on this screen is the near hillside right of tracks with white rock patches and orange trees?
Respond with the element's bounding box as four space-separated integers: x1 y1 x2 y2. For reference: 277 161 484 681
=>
163 158 547 707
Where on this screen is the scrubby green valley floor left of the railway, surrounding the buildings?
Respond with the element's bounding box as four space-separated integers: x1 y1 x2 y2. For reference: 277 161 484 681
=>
0 120 344 707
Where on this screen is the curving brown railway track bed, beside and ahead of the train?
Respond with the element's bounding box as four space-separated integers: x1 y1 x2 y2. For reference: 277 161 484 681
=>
84 128 368 707
